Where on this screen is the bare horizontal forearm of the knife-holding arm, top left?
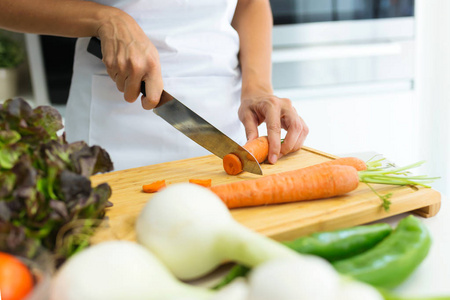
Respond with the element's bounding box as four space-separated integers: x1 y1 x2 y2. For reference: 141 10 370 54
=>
0 0 128 37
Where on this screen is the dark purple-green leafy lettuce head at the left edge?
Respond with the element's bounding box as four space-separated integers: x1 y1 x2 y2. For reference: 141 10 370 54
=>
0 98 113 262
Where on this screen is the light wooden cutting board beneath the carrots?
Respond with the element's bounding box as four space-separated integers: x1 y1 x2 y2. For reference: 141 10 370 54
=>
91 147 441 243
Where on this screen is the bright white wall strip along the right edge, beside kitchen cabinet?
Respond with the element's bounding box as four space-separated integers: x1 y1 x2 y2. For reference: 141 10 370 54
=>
415 0 450 195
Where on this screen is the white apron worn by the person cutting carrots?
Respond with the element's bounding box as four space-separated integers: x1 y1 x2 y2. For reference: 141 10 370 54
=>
66 0 245 171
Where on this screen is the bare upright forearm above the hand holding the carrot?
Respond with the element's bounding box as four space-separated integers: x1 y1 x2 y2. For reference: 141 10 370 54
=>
232 0 273 95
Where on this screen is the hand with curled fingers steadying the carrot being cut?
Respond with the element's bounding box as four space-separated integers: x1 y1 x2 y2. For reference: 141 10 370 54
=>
238 93 309 164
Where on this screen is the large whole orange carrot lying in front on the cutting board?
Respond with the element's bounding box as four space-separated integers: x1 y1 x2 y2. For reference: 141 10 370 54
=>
210 164 359 208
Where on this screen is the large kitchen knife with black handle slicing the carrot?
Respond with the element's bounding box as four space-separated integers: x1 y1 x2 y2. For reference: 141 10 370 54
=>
87 37 262 175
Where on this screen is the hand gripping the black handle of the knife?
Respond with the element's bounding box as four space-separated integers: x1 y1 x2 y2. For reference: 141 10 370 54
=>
97 11 163 109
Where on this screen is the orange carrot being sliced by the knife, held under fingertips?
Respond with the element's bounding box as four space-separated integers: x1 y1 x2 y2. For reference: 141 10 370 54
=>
223 136 269 175
